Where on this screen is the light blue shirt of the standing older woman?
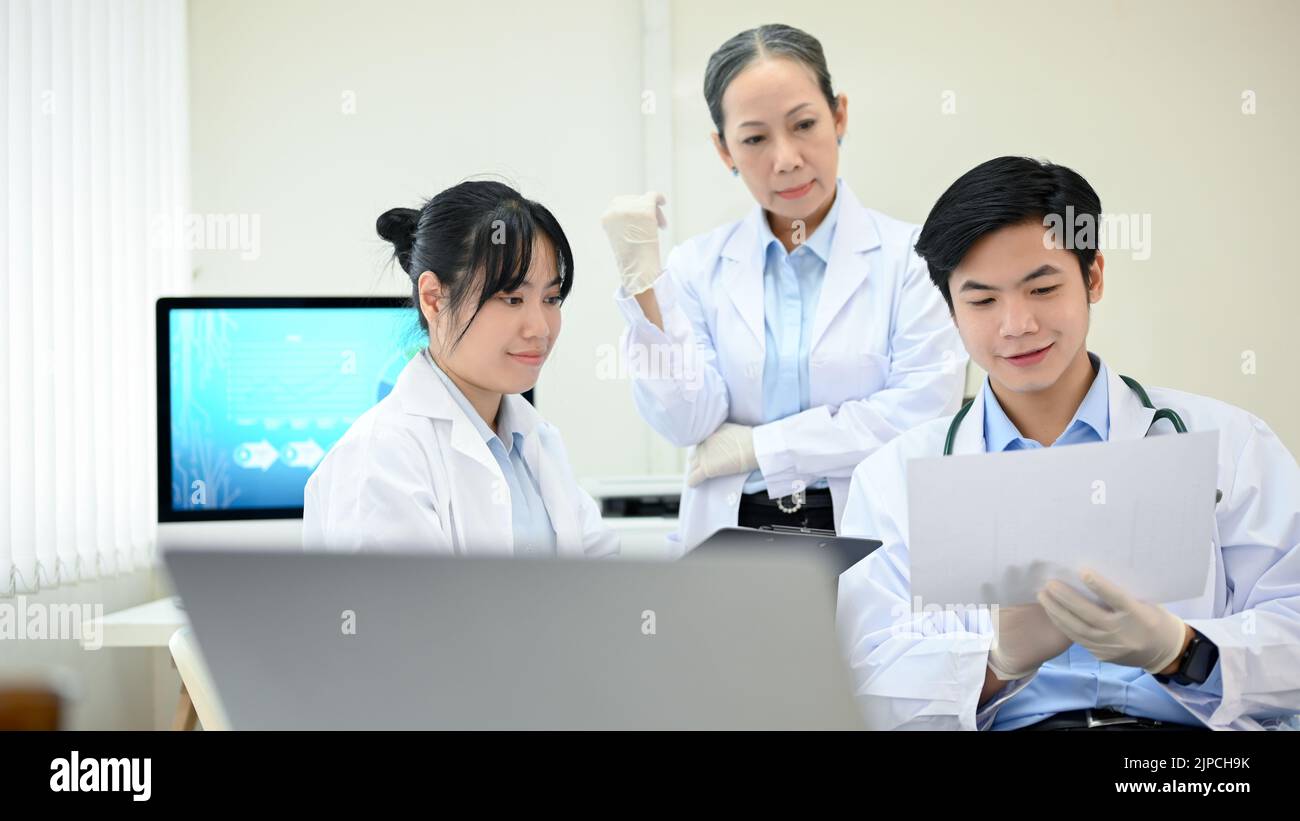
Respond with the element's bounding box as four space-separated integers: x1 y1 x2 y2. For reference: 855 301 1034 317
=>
744 181 842 494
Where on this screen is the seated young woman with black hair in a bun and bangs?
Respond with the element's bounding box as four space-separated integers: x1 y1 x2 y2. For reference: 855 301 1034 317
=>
303 182 619 556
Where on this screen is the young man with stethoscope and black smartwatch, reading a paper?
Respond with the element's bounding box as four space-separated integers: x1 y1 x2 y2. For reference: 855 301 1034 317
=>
839 157 1300 730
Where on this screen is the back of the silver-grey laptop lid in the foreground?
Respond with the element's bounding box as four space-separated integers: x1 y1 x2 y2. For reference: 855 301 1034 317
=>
164 549 862 730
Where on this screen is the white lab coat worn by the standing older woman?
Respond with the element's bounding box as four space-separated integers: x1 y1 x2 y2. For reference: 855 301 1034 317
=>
616 183 967 555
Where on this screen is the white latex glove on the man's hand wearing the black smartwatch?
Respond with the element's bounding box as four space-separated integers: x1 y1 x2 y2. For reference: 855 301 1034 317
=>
1039 570 1187 673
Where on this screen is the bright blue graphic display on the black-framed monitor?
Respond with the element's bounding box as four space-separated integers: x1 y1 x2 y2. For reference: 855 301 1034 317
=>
169 308 426 511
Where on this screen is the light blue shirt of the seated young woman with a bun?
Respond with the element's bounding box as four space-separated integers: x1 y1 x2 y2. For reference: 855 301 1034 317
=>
421 348 555 556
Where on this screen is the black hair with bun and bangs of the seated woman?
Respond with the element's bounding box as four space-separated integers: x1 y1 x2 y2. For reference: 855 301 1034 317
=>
374 181 573 346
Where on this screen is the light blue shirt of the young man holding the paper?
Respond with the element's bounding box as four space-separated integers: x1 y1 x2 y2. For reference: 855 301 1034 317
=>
976 353 1222 730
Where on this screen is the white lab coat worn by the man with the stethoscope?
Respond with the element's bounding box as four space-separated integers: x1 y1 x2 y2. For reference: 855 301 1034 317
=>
837 370 1300 730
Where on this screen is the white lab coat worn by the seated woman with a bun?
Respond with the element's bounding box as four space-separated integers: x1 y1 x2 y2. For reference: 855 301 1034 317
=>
303 356 619 557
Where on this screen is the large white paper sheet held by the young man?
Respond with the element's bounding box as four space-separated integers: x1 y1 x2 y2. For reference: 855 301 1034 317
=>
907 431 1218 607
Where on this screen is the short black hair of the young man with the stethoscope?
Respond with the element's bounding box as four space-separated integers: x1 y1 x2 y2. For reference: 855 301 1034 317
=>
917 157 1101 310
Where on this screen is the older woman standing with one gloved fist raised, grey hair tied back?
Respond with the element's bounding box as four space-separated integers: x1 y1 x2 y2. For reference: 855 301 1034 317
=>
603 25 966 553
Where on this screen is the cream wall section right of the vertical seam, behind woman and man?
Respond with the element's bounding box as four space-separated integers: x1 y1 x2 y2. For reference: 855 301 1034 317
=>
672 0 1300 453
